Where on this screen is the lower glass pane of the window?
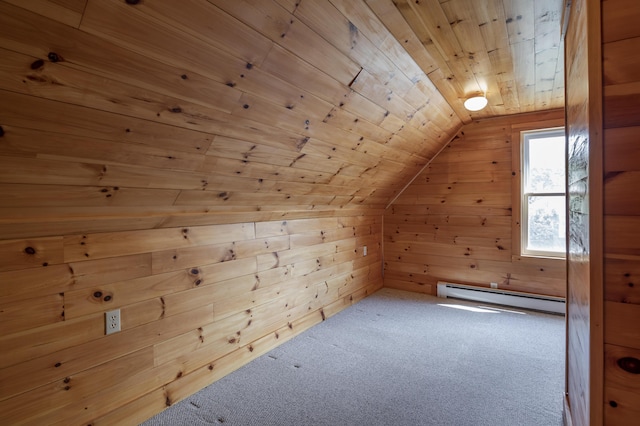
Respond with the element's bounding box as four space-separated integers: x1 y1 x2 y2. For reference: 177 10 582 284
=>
527 196 566 253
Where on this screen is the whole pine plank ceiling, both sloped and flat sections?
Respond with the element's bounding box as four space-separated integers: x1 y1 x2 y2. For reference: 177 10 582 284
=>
0 0 563 238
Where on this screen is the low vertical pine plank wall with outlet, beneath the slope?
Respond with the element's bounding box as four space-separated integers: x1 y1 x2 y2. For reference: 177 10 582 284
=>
0 216 382 425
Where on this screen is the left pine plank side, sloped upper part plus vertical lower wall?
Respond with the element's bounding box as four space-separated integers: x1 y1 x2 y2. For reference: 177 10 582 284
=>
0 0 436 425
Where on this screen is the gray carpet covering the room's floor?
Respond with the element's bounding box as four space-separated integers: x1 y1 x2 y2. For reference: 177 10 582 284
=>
144 289 565 426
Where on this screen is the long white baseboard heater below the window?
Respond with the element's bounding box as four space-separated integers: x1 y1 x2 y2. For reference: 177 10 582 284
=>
438 281 566 315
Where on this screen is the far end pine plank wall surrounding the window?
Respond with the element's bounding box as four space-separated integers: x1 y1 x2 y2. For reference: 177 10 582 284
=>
383 110 565 296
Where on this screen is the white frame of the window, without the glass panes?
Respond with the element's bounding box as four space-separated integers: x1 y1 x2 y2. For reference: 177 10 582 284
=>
520 127 567 259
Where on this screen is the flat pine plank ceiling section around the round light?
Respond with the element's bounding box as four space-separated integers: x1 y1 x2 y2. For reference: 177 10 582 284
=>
376 0 564 122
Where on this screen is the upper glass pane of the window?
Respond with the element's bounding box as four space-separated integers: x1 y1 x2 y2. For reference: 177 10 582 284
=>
526 136 565 192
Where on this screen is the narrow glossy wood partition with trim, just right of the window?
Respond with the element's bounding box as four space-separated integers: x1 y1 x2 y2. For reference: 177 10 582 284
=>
565 0 603 425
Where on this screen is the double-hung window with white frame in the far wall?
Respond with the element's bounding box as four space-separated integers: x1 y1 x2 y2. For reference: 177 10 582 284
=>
520 128 566 257
